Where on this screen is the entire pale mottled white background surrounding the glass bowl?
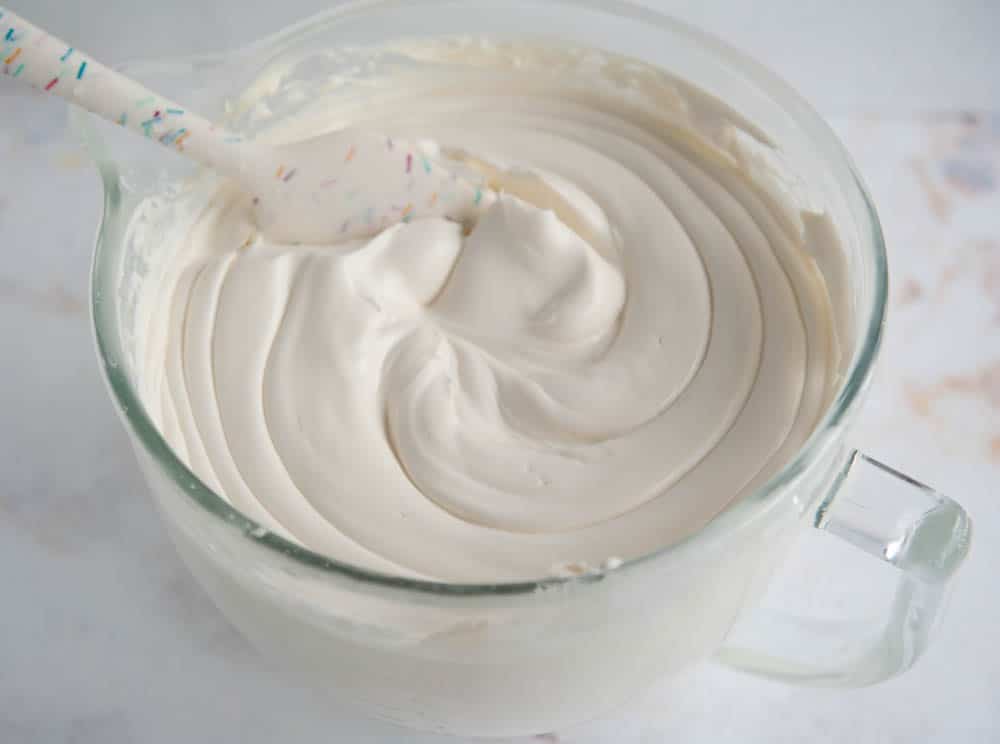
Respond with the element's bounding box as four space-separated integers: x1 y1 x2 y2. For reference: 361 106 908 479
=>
0 0 1000 744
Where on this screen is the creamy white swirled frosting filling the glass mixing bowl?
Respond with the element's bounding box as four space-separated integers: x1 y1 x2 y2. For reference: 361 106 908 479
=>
136 42 838 582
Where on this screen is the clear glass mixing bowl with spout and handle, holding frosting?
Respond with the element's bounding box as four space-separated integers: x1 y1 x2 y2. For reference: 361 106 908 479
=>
75 0 970 736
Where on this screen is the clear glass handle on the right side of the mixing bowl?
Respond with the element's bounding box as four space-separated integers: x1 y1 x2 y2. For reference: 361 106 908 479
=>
717 451 972 687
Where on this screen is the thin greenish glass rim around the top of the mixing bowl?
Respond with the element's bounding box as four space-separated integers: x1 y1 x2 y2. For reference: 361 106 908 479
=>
84 0 888 597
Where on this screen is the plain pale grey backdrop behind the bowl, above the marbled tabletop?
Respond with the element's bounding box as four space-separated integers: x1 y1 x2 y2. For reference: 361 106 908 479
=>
5 0 1000 114
